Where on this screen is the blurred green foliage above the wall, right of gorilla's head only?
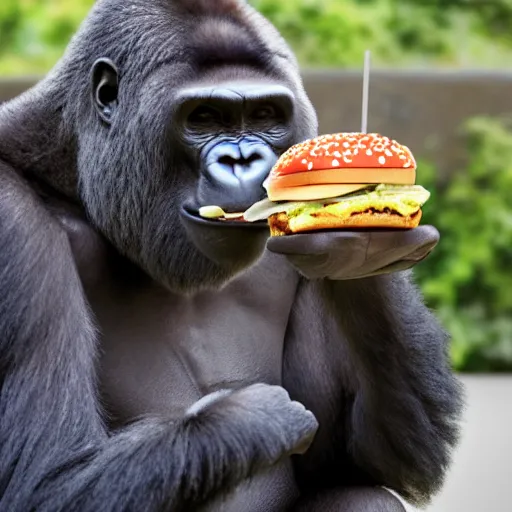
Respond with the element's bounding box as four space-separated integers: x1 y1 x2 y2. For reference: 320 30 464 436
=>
250 0 512 68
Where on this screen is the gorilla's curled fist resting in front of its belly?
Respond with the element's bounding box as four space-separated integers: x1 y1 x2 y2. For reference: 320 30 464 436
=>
188 384 318 460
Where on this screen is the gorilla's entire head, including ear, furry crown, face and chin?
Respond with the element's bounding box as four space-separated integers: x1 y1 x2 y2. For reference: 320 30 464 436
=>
68 0 317 292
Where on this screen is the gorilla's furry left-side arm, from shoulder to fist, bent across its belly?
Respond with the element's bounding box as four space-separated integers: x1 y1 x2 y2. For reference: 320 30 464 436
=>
0 162 316 511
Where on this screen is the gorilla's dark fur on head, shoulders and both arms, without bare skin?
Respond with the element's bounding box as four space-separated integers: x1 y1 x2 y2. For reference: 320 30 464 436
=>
0 0 460 512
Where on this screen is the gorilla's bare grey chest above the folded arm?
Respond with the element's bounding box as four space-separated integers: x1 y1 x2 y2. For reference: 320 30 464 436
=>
92 255 296 423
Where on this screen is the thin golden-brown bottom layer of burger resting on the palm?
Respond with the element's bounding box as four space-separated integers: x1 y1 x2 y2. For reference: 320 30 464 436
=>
268 210 422 236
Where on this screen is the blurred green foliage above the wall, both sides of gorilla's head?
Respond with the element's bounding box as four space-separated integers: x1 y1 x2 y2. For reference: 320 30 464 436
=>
0 0 512 75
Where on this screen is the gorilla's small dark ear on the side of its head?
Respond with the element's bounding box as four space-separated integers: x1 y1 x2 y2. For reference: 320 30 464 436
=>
92 59 119 124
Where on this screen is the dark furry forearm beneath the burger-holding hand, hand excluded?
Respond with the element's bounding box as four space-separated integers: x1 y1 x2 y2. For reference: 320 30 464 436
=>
284 273 461 504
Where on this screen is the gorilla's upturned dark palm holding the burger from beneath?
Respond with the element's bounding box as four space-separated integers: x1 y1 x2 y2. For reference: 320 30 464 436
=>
267 226 439 280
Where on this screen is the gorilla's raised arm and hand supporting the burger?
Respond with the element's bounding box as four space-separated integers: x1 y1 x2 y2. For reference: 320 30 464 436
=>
269 231 461 511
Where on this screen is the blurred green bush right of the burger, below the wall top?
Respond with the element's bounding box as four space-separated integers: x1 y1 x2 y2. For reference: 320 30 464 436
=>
417 118 512 371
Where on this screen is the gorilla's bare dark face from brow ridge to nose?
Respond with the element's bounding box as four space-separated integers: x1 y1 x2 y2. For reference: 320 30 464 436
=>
176 79 294 212
